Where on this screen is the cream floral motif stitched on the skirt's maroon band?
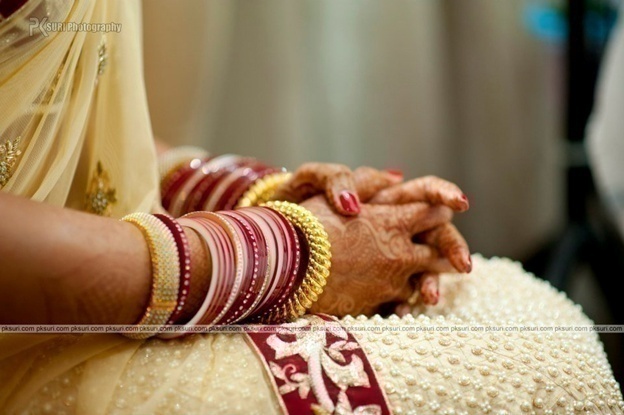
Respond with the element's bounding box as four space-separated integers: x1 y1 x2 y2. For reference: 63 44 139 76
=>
267 316 382 415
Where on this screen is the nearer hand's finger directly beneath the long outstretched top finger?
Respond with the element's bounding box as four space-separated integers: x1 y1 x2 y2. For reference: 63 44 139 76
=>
366 203 453 238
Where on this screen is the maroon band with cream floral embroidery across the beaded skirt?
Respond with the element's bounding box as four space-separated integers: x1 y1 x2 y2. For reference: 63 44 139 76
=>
249 316 389 415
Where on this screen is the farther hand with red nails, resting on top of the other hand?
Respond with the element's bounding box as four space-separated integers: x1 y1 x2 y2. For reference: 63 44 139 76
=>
273 163 468 216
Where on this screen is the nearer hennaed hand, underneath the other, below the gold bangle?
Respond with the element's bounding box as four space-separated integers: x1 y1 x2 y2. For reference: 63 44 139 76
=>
302 196 469 316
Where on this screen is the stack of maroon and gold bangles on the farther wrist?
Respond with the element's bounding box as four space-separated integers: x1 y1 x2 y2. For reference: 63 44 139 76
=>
159 147 291 217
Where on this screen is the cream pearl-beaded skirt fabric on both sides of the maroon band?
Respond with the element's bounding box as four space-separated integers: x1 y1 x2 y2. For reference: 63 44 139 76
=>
0 256 624 415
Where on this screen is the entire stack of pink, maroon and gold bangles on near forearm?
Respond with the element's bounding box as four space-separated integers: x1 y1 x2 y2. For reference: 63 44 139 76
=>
122 202 331 339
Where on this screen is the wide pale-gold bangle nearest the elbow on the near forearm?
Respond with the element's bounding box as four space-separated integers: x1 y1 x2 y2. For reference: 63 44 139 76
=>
121 212 180 339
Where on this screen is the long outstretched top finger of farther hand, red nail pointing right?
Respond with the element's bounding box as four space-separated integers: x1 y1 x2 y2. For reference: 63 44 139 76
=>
369 176 470 212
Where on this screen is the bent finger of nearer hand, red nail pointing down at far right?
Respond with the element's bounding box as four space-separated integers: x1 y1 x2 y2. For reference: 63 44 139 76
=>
418 223 472 273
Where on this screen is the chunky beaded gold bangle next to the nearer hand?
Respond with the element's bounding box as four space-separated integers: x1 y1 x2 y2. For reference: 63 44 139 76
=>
262 201 331 323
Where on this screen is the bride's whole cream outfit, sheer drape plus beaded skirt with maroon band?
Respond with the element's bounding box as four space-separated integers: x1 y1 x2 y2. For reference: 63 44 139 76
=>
0 0 624 414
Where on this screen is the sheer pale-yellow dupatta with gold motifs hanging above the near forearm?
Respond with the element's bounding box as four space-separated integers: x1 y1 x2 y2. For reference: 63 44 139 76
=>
0 0 158 217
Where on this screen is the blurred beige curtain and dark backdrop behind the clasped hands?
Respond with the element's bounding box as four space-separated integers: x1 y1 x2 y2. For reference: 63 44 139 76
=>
144 0 624 382
